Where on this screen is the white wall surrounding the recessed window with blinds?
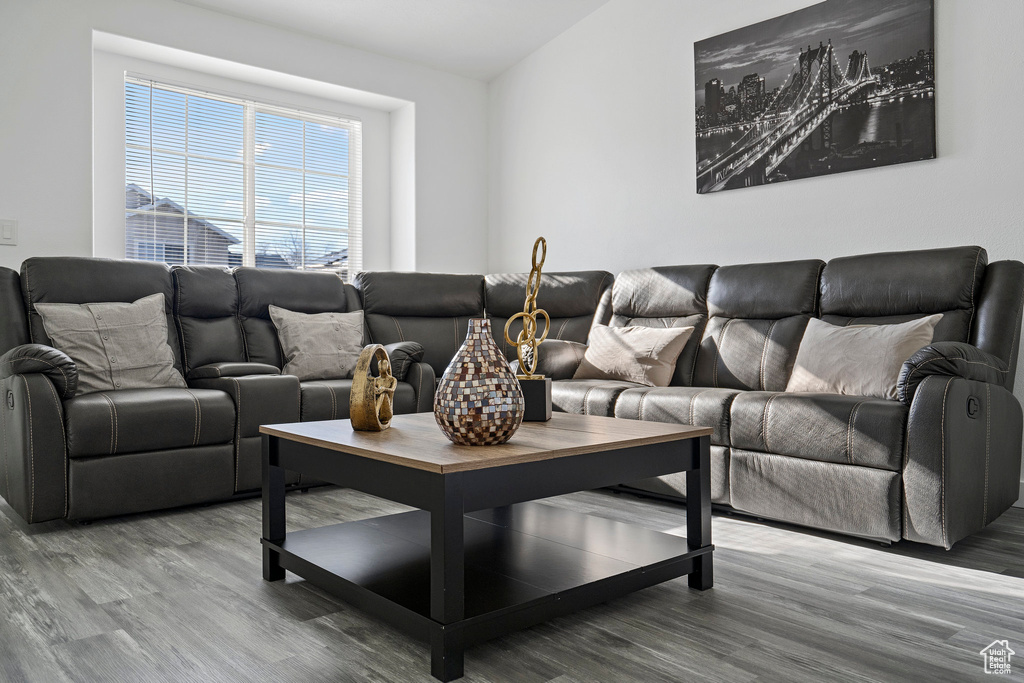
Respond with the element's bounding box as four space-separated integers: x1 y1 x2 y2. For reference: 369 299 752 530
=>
0 0 487 272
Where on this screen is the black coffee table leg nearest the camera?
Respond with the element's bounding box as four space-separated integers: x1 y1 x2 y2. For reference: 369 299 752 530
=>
430 473 466 681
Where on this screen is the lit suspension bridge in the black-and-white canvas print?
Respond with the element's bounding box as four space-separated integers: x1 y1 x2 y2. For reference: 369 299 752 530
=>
697 41 879 193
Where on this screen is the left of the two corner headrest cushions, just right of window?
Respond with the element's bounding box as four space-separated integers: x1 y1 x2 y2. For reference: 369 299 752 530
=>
353 272 483 317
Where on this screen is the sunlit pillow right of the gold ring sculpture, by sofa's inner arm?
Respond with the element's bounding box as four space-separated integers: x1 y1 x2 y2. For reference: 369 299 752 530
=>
572 325 693 387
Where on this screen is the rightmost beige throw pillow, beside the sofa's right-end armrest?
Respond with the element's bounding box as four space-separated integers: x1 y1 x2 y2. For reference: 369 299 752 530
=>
785 313 942 400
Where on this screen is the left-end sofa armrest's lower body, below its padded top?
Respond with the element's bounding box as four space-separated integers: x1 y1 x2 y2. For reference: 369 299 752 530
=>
0 368 68 524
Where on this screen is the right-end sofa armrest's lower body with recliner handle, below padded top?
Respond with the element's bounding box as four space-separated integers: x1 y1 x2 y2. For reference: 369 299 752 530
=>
903 375 1024 548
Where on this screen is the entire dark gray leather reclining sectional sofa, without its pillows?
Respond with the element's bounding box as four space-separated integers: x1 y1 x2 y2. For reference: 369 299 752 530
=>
0 247 1024 547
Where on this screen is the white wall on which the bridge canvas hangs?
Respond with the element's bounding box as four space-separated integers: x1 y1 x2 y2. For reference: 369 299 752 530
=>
488 0 1024 501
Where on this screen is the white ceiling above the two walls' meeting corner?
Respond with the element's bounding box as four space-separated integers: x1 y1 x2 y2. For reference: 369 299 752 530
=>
172 0 608 81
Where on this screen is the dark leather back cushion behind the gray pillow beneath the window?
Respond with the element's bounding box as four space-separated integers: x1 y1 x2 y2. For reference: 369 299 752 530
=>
234 267 360 368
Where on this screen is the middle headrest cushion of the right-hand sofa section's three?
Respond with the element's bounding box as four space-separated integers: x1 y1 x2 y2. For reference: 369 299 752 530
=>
708 260 824 319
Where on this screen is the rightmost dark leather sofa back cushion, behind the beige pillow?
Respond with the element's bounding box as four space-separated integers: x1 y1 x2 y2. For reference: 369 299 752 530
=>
820 247 988 342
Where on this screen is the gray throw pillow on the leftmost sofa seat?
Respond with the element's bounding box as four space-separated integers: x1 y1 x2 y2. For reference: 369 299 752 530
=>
36 294 185 395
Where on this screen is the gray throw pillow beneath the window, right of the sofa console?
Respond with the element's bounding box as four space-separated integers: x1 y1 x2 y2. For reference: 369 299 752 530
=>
270 306 362 380
